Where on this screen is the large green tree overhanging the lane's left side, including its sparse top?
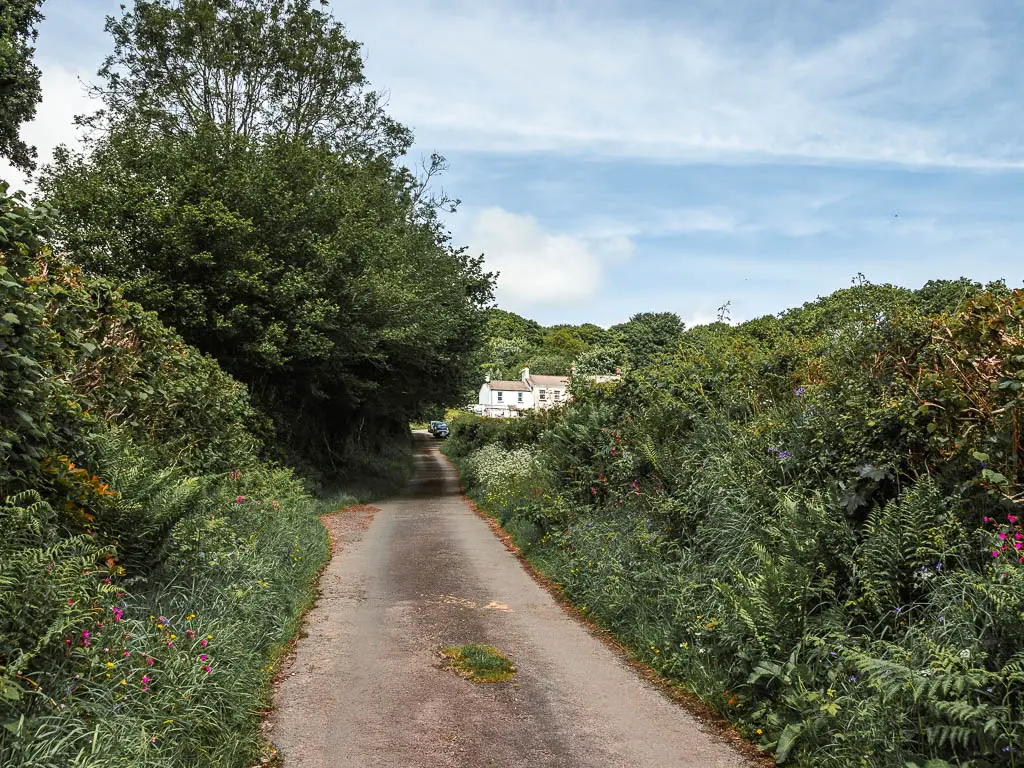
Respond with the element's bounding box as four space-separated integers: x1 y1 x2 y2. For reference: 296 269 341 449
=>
42 0 492 475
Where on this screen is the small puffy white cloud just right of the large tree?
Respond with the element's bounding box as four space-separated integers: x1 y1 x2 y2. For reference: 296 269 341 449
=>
468 208 633 310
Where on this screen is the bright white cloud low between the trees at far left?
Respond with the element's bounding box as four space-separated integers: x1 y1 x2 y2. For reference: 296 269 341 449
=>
0 60 96 189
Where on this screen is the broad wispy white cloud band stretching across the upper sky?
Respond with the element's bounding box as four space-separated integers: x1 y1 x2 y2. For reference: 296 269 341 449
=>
339 0 1024 168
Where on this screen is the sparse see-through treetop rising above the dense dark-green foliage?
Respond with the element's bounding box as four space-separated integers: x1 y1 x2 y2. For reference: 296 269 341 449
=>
87 0 412 160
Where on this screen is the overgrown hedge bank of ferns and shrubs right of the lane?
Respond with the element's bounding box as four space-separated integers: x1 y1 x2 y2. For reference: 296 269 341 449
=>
444 282 1024 768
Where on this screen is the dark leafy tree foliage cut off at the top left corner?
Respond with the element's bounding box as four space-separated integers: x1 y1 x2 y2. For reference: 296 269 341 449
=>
0 0 43 171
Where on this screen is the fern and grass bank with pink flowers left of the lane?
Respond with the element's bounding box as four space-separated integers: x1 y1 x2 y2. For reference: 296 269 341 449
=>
0 185 345 766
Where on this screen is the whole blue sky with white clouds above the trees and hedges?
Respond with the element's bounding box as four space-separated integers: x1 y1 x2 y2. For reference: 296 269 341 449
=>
0 0 1024 326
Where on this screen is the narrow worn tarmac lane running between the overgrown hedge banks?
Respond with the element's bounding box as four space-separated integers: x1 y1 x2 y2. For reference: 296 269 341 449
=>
271 435 749 768
